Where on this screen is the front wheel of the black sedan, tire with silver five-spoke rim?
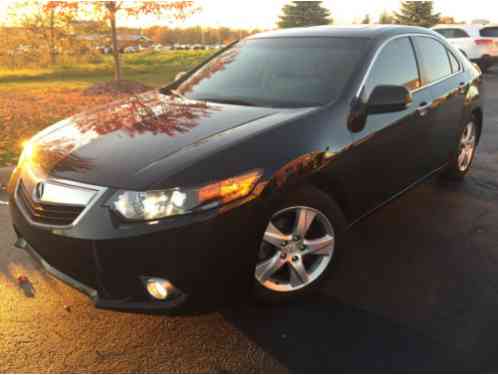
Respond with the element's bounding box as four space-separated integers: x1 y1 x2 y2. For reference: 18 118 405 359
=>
254 186 346 304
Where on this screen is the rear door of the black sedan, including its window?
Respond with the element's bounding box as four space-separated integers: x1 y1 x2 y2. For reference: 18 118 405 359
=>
413 36 467 169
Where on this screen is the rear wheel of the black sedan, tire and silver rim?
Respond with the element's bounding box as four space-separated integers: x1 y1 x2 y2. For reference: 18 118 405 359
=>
442 118 479 180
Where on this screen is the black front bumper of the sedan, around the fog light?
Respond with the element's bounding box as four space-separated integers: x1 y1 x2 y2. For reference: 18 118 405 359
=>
10 175 265 311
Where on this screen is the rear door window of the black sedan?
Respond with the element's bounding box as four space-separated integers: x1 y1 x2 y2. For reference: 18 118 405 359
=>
415 37 451 83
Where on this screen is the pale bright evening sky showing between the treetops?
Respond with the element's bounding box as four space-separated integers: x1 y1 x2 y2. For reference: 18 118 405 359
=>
0 0 498 29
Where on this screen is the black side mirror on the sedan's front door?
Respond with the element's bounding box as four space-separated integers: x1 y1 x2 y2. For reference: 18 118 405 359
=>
368 86 413 114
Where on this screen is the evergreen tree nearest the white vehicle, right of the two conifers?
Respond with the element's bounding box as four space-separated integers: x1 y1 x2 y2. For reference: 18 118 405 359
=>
394 1 441 27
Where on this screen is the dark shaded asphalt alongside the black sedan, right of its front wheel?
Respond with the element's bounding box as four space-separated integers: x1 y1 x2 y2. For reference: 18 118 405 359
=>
223 173 498 373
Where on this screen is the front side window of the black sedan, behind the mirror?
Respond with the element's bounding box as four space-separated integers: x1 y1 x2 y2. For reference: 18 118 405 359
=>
365 38 420 97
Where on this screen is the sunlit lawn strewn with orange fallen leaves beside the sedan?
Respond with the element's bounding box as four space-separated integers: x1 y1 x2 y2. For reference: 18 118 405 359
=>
0 51 209 167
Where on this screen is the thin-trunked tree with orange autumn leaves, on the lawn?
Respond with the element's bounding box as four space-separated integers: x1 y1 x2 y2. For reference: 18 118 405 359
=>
45 0 196 82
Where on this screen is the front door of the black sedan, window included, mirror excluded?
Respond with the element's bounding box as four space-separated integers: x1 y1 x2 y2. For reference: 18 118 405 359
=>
348 37 432 216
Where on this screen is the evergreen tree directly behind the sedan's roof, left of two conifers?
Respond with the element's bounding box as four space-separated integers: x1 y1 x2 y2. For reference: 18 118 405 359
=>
278 1 332 29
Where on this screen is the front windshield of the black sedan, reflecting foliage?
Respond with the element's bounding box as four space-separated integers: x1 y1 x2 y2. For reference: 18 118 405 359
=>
176 37 367 108
